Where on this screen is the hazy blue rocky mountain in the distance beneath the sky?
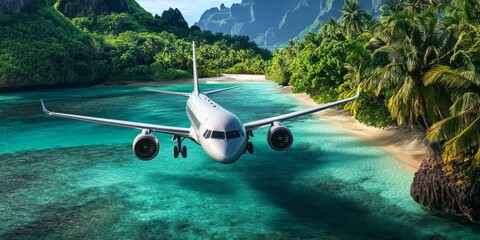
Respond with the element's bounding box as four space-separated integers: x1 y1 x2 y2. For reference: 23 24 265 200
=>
196 0 385 47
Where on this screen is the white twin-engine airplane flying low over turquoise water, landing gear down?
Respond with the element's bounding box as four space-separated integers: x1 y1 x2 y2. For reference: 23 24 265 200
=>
40 42 360 164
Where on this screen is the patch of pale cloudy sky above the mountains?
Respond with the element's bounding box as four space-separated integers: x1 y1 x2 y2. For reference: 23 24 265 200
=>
137 0 241 26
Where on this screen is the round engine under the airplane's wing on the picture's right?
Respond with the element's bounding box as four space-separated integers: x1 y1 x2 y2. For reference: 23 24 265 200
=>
267 122 293 151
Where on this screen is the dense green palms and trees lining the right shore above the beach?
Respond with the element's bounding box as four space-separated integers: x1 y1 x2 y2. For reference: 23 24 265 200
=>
268 0 480 168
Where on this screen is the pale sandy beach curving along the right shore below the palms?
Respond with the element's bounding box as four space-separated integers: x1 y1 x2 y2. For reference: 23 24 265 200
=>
201 74 433 171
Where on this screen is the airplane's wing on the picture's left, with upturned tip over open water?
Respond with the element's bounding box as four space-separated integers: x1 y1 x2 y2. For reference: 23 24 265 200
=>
40 100 190 138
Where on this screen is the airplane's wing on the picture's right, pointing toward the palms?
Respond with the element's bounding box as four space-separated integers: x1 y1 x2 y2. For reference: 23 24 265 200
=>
244 90 360 132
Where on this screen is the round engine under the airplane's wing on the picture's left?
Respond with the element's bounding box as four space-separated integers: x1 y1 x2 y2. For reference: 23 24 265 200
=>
133 129 160 161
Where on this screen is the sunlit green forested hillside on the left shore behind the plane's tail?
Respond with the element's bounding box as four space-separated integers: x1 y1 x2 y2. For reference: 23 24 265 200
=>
0 0 271 87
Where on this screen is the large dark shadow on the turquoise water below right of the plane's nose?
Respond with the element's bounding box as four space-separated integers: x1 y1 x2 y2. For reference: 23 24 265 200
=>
235 141 419 239
